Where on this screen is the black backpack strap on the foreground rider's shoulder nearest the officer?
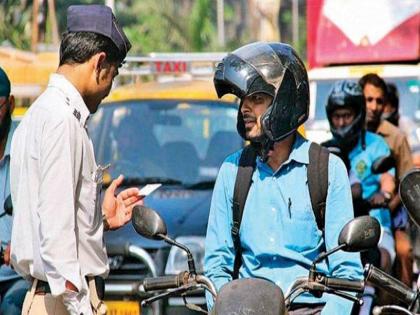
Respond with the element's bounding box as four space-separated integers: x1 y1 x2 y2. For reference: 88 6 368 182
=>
231 145 257 279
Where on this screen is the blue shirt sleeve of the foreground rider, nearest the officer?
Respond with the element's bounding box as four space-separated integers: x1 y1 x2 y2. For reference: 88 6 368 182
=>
204 163 235 309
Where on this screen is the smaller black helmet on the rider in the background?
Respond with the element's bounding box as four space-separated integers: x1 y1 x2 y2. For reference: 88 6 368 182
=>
326 80 366 146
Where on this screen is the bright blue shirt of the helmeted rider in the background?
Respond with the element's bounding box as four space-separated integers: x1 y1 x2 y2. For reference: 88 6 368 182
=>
349 131 391 231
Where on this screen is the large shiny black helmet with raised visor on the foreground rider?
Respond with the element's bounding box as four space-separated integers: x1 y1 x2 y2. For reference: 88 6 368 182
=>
214 42 309 142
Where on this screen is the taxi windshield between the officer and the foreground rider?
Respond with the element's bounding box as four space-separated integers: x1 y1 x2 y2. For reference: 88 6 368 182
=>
89 100 243 185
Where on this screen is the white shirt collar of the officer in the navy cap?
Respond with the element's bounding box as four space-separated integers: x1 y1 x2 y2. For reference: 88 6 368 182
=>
48 73 90 126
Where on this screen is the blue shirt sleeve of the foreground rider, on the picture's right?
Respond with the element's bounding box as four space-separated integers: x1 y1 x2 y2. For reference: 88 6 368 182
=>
322 154 363 314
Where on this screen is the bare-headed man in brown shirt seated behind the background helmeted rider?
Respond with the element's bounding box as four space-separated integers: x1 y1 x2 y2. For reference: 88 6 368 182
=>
359 73 414 287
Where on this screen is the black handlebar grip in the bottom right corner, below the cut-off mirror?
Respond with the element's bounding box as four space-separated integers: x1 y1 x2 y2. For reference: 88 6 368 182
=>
365 264 417 305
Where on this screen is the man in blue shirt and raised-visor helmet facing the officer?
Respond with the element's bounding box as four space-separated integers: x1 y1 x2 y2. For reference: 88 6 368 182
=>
205 42 362 314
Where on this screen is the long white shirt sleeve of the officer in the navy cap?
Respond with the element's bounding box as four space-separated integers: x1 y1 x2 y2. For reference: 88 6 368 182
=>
37 117 82 295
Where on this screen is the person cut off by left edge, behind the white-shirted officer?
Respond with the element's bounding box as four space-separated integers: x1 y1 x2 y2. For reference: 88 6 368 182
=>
0 67 29 315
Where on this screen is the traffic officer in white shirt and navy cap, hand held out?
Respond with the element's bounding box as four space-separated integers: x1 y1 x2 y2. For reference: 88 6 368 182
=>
10 5 142 315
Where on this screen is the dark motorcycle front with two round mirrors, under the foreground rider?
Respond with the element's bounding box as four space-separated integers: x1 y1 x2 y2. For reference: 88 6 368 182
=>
132 206 380 315
